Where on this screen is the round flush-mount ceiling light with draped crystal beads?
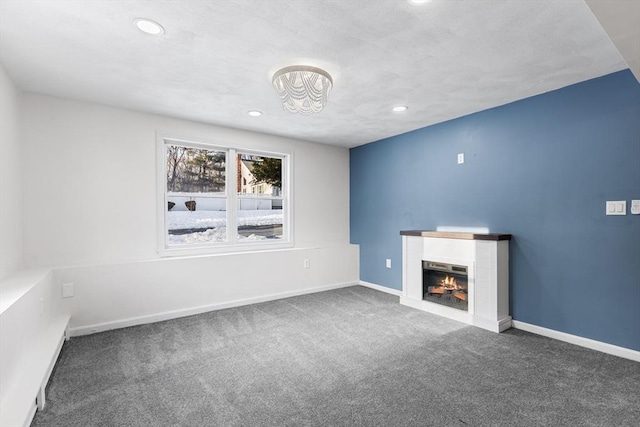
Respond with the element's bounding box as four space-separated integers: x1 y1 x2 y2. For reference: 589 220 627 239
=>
271 65 333 116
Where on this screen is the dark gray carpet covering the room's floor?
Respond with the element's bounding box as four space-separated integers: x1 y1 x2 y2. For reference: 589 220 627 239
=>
32 286 640 427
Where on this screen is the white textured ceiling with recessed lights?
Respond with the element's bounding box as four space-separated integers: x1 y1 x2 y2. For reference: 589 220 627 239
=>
0 0 640 147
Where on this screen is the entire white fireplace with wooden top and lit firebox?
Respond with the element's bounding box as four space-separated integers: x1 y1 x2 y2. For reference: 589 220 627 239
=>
400 230 511 332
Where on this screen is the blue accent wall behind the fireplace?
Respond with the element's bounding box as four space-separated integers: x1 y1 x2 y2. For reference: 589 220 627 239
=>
350 70 640 350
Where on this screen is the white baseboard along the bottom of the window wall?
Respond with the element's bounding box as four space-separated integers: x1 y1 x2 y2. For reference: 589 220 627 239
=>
69 282 357 337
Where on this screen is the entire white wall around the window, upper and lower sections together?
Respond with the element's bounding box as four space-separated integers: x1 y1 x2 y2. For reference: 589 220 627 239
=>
21 94 358 333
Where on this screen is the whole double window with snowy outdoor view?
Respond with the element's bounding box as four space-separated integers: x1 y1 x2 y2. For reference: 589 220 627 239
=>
158 138 292 254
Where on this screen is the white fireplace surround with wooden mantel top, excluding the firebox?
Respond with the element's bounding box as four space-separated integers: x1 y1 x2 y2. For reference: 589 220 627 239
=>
400 230 511 332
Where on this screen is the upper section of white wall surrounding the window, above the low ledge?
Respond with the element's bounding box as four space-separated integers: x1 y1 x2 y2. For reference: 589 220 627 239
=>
22 94 349 267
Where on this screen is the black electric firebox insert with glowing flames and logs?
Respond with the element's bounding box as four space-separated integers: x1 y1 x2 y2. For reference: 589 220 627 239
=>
422 261 469 311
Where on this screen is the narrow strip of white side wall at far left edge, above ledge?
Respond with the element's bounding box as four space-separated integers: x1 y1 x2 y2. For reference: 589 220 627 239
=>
0 65 22 280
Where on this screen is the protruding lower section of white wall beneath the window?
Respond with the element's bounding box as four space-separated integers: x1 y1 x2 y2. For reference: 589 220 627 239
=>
54 245 358 335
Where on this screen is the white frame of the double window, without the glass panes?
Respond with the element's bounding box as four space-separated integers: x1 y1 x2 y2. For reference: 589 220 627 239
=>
156 133 294 256
